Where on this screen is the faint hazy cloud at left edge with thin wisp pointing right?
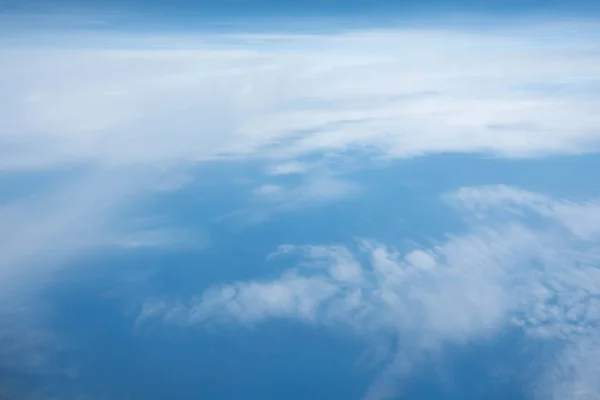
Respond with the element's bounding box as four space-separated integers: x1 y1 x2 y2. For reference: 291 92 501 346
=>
0 168 202 373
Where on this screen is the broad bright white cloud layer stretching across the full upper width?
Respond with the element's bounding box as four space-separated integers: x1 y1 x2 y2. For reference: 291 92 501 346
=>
0 23 600 172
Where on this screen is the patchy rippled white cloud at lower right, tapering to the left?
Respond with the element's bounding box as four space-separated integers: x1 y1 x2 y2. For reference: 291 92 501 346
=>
139 186 600 400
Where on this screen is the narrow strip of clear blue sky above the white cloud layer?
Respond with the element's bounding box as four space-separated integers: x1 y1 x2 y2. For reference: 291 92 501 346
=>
0 0 600 33
